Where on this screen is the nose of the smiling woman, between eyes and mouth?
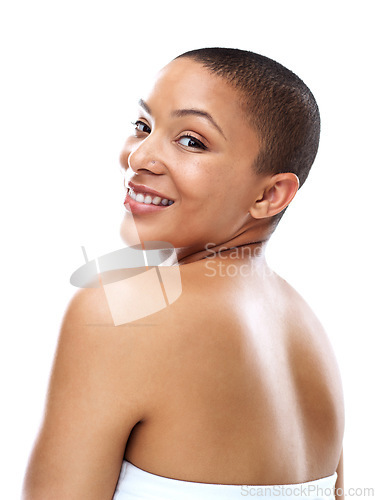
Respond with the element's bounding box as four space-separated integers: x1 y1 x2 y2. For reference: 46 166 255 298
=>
120 136 166 175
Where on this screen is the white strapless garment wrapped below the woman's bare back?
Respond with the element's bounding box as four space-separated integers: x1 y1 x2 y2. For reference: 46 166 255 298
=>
113 460 337 500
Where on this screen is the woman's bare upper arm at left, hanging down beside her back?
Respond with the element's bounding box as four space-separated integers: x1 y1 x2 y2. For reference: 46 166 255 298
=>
24 289 155 500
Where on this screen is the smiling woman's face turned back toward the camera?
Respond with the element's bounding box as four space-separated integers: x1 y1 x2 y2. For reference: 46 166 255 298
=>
120 58 262 251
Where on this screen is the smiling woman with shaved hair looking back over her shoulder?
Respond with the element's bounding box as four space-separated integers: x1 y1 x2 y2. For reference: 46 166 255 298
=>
24 48 344 500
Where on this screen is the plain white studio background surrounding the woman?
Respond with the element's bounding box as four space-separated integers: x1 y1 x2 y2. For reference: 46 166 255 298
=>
0 0 375 499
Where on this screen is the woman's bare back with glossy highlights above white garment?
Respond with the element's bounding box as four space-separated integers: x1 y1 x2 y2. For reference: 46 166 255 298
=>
125 254 344 484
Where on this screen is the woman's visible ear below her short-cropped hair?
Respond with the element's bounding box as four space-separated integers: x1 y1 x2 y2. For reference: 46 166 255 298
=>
249 172 299 219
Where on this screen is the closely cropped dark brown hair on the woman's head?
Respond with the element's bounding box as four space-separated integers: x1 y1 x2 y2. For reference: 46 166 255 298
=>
176 47 320 192
